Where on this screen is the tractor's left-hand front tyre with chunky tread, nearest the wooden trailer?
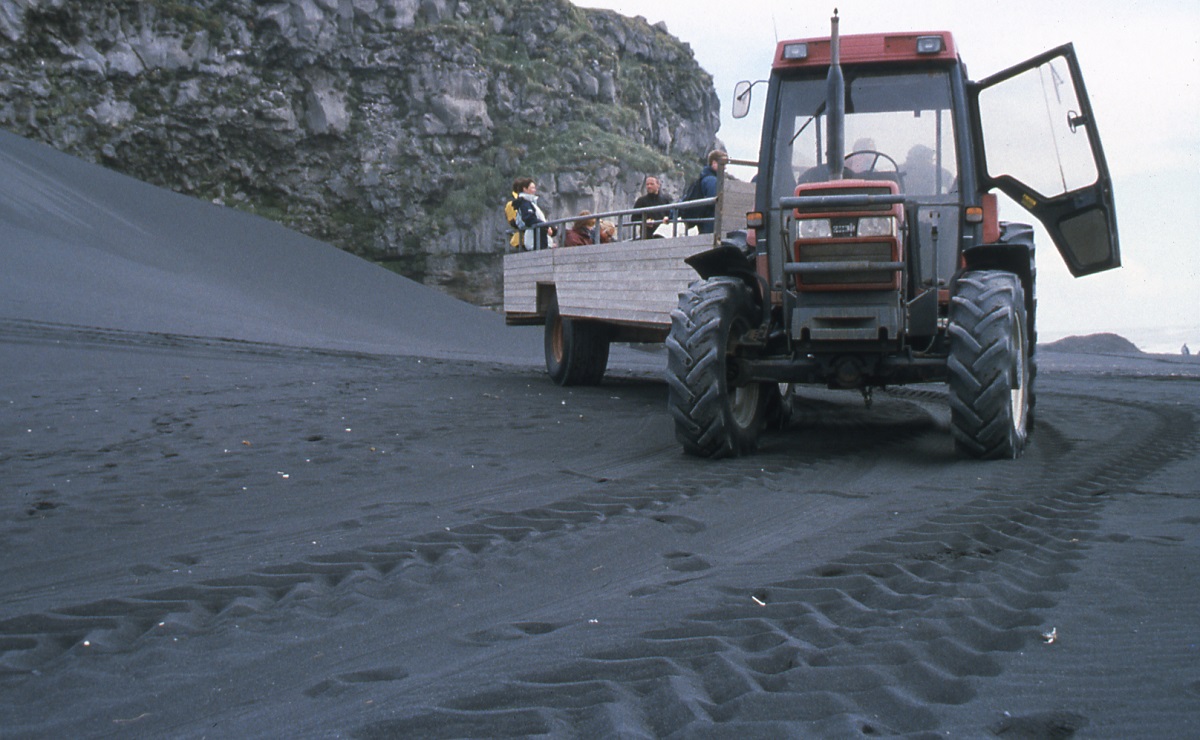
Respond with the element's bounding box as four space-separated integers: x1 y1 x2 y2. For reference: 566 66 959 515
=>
667 277 778 457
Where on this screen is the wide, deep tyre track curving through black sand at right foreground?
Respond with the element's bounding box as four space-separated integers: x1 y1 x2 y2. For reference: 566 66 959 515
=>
354 388 1198 738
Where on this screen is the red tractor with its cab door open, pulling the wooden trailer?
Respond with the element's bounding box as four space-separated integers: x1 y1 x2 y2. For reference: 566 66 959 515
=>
667 17 1120 458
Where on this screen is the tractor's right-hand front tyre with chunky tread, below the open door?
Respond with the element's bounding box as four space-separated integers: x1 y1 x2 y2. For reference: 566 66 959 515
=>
948 270 1033 459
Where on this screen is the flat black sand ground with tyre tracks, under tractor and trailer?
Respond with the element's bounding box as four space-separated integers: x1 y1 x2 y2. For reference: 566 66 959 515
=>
0 131 1200 738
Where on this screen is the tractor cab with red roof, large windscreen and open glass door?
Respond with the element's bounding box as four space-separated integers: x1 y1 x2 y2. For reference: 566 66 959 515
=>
734 25 1121 314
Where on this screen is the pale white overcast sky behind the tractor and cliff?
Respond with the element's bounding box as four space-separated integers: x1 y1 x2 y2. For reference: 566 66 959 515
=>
574 0 1200 353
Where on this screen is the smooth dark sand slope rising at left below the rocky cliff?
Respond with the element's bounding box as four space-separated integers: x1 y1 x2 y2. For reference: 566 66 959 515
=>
0 132 538 362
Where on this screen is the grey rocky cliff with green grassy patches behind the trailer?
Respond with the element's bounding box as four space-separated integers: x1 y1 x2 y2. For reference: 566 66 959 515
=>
0 0 719 303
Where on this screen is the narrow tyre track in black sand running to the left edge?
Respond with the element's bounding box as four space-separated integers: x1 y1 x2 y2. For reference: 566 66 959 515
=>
0 402 928 678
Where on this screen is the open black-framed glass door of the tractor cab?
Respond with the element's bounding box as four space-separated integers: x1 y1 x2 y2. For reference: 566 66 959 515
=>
970 43 1121 277
